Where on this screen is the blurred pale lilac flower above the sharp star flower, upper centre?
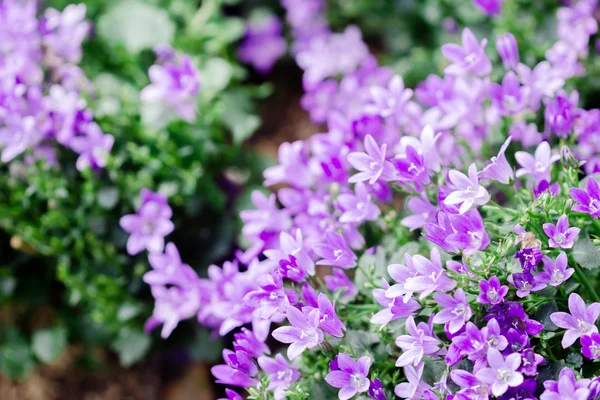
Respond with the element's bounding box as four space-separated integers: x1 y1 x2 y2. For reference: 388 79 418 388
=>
365 75 413 118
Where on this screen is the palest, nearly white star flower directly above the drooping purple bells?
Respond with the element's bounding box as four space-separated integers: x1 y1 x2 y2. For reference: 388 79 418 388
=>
444 163 490 214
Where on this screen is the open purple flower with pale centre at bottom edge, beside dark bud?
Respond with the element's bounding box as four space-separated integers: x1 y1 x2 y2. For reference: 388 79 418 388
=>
325 353 373 400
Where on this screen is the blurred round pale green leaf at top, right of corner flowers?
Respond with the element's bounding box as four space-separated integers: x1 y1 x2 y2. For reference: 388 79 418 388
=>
98 0 175 54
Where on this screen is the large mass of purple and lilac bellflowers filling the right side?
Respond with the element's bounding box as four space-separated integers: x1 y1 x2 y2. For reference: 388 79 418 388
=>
127 0 600 400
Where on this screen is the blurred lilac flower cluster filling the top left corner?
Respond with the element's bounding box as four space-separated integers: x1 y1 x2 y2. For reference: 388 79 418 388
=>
0 0 114 170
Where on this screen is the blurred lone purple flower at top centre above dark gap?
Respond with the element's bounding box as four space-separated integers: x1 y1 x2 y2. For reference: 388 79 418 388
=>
238 15 287 74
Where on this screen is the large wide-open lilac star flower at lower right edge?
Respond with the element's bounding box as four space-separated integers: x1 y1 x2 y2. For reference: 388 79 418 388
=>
550 293 600 349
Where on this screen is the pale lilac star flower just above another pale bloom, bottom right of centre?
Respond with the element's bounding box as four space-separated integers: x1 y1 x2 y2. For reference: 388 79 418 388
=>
396 316 440 367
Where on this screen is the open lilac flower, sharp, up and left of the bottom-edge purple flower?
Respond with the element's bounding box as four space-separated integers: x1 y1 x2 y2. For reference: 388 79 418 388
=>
272 307 323 360
